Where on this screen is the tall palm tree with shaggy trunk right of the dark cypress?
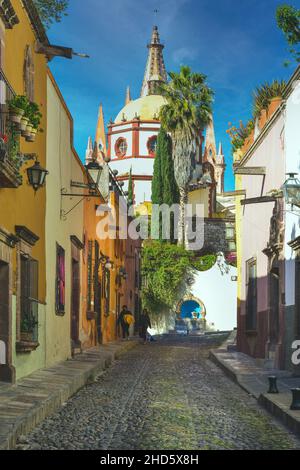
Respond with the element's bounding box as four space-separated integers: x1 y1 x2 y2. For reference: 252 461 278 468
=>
160 66 213 245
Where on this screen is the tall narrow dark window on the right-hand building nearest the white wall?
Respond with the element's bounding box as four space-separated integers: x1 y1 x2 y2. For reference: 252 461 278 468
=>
246 258 257 330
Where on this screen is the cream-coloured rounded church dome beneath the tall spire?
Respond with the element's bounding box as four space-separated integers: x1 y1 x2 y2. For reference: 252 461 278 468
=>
115 95 166 124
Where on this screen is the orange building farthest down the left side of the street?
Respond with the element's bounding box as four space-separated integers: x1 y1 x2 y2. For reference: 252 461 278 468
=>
81 174 141 348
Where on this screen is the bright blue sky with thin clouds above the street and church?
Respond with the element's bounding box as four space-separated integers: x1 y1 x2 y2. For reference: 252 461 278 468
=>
49 0 300 190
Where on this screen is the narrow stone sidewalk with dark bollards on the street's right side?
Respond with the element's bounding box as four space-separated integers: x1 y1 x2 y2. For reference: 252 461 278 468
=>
210 332 300 435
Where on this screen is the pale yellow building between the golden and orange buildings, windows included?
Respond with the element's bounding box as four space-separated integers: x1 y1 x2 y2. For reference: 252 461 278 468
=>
45 71 86 366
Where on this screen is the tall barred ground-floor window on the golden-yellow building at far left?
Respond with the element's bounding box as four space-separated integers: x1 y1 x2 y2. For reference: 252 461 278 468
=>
20 255 39 342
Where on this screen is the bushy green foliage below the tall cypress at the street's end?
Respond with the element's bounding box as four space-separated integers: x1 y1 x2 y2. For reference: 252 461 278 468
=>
142 241 191 315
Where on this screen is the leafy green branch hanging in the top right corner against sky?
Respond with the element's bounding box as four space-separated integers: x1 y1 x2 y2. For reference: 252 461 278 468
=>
276 4 300 62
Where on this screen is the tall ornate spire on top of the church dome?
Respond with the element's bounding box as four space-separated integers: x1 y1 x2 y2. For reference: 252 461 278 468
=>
141 26 167 97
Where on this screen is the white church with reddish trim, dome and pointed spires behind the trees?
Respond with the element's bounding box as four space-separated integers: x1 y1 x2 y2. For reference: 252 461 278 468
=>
86 26 225 206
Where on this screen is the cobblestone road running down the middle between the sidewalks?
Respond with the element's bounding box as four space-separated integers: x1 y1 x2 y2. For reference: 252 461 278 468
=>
19 337 300 450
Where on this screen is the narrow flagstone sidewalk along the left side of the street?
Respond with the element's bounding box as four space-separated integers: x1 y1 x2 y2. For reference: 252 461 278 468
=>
0 339 137 450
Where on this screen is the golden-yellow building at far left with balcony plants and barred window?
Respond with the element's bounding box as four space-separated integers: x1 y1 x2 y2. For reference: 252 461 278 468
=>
0 0 48 381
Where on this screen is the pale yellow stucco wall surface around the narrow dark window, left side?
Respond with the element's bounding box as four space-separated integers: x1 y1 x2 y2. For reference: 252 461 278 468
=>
46 77 83 365
